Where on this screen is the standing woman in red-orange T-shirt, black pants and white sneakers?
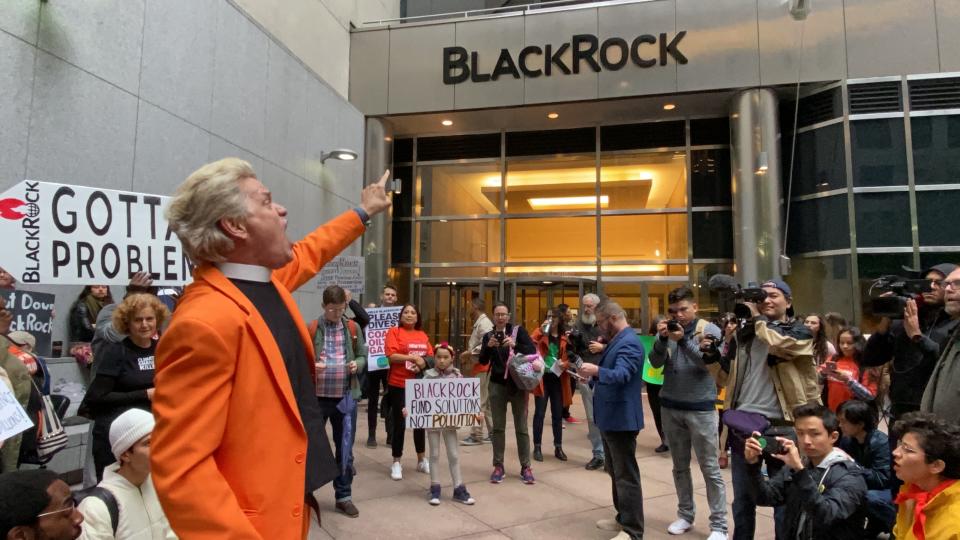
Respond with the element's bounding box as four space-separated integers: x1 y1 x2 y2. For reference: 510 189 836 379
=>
384 304 433 480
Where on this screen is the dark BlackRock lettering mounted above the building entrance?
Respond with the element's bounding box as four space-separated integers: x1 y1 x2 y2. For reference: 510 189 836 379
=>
443 30 687 84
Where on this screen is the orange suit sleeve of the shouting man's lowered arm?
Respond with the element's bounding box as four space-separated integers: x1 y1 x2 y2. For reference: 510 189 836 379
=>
150 319 261 540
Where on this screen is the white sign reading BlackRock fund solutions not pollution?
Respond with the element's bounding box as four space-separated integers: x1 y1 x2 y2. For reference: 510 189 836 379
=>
404 378 483 429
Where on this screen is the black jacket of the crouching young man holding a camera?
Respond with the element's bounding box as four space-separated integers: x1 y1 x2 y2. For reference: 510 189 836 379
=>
749 452 867 540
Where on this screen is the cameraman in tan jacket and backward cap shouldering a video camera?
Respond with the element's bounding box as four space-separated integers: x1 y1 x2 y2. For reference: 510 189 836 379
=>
701 279 820 539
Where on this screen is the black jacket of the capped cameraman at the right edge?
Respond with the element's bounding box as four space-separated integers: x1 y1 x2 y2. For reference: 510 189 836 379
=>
861 309 960 418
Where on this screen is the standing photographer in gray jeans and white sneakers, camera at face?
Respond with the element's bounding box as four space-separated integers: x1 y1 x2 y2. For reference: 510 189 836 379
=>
650 287 727 540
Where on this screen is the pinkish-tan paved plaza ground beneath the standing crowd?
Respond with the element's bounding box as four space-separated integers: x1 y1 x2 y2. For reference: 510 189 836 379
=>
310 394 774 540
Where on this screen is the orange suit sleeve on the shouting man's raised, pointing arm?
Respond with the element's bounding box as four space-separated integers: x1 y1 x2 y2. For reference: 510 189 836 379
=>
273 210 365 291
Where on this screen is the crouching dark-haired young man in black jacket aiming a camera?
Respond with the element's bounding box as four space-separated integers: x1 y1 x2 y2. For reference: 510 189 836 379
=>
743 404 867 540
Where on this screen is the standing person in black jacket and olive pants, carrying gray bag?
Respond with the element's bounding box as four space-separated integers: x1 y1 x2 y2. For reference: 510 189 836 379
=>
478 302 537 484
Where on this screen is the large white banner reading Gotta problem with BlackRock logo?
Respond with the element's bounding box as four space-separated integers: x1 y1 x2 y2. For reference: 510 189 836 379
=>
0 180 191 285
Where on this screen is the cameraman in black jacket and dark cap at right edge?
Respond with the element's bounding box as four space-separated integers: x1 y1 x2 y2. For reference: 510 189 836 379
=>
863 264 957 422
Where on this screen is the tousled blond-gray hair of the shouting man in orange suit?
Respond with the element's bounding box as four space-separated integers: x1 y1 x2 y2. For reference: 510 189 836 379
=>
165 158 257 264
